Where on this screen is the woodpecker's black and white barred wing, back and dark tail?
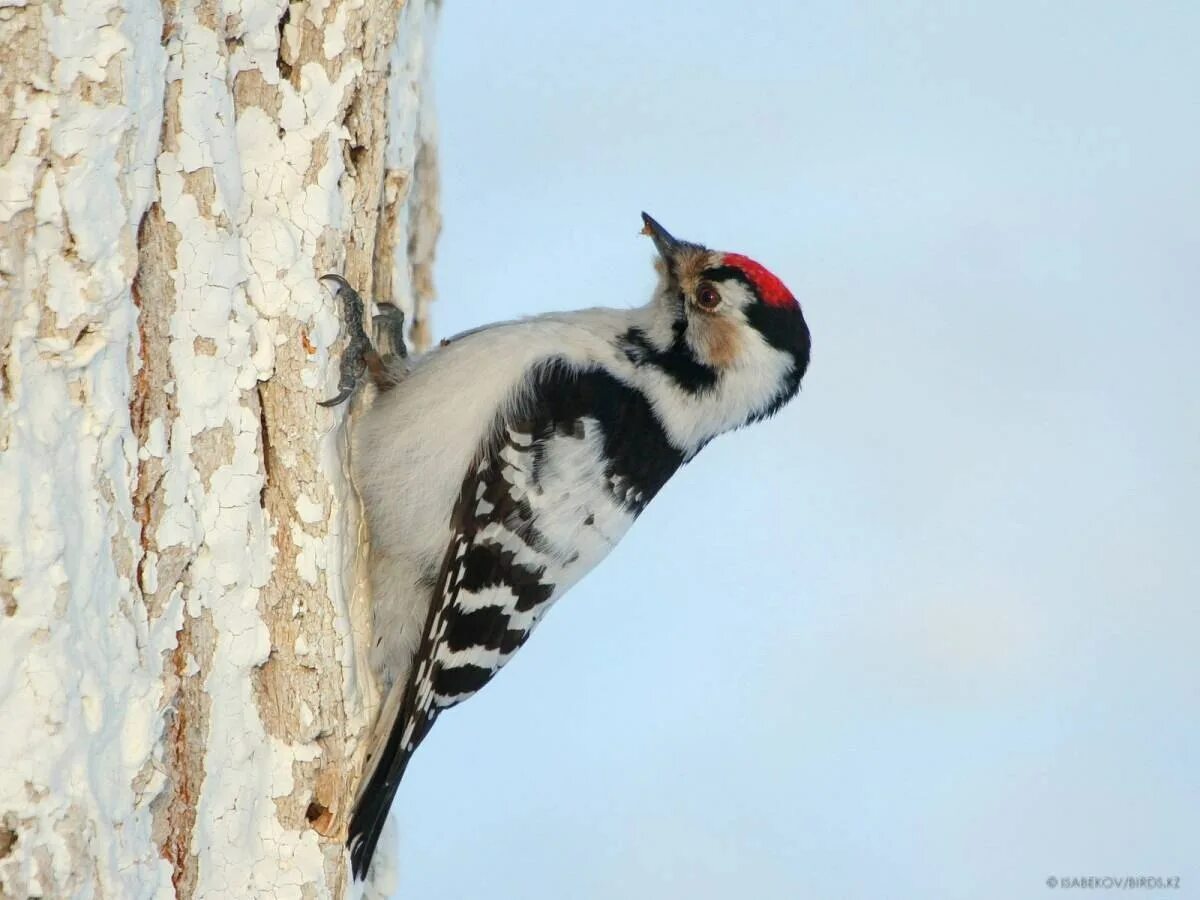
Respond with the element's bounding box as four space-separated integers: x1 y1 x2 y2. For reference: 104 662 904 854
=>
348 361 684 877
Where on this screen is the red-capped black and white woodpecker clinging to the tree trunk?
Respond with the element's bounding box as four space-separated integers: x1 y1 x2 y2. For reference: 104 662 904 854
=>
325 214 810 878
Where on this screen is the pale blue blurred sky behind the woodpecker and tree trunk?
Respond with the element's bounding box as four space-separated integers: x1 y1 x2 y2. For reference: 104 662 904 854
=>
388 0 1200 900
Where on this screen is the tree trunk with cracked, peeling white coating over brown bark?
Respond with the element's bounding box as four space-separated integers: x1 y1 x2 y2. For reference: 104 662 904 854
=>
0 0 439 900
